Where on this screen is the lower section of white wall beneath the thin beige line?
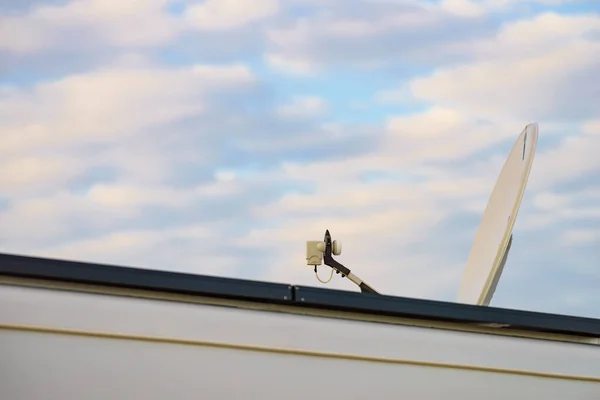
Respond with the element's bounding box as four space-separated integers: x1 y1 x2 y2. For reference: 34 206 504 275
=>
0 332 600 400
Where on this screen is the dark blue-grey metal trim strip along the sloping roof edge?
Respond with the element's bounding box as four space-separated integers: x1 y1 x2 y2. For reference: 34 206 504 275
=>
0 254 600 338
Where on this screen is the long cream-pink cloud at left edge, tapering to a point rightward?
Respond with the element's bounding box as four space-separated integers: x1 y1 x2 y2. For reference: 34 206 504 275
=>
0 65 255 147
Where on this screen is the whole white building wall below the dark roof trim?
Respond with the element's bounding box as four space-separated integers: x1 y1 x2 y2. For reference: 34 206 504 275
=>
0 285 600 400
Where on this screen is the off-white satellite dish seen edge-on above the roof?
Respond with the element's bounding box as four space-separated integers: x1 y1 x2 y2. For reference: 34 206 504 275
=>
457 123 538 306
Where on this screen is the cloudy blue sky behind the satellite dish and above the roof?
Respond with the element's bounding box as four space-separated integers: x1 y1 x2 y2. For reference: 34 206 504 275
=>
0 0 600 318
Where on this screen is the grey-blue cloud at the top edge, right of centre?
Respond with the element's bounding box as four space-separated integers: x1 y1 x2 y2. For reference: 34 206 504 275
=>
266 0 491 74
